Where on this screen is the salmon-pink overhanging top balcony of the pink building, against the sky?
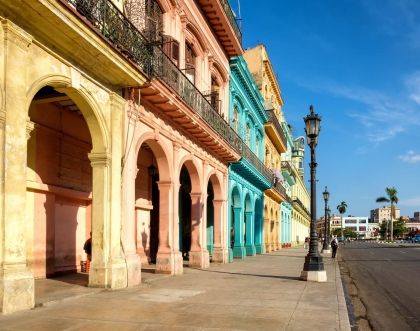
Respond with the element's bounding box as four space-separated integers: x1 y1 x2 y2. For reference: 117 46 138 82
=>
196 0 243 57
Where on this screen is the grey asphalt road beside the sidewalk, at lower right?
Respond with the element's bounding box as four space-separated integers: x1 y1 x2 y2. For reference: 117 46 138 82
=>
339 242 420 331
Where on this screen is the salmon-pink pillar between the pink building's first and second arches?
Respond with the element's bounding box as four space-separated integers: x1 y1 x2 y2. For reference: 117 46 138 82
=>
156 181 182 275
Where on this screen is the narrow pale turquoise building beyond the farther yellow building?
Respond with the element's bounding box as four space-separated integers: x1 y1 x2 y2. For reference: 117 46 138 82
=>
280 122 296 247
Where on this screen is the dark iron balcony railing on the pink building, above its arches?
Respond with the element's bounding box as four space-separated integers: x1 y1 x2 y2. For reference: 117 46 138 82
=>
152 46 242 152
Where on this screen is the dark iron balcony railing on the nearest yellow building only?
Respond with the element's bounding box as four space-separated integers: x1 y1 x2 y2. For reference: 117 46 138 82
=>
67 0 152 75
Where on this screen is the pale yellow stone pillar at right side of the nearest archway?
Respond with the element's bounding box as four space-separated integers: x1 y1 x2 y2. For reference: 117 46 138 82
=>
88 153 127 288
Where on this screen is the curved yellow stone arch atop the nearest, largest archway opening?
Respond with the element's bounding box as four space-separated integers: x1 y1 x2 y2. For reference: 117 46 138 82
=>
26 74 110 153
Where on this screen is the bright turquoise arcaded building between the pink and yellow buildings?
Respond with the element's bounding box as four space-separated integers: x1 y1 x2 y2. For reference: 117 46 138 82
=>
228 57 273 261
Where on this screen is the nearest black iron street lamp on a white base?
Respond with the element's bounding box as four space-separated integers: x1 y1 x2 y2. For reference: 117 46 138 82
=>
300 105 327 282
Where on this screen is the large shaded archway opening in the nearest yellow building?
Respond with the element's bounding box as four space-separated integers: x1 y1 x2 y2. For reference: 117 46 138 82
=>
26 86 95 283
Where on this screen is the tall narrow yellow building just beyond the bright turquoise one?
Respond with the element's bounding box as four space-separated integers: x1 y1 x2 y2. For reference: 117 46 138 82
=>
244 45 287 252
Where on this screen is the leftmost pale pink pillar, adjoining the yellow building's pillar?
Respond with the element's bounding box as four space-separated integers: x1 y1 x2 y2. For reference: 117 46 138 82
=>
121 100 144 286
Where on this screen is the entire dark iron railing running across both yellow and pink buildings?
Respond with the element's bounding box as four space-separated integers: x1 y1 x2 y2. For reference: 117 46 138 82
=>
67 0 242 152
